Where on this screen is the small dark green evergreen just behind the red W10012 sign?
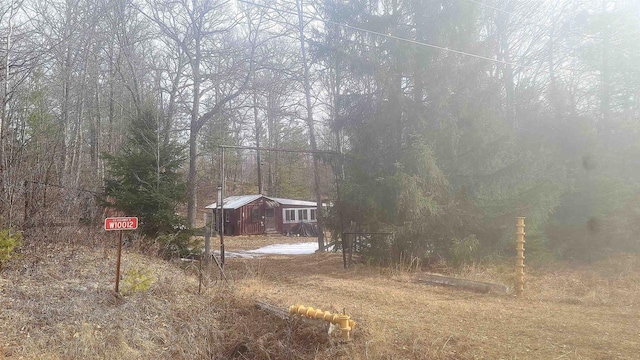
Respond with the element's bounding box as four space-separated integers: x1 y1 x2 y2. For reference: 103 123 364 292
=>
104 106 186 236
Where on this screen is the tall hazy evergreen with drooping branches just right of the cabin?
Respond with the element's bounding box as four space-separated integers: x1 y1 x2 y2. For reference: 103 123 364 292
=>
317 1 484 261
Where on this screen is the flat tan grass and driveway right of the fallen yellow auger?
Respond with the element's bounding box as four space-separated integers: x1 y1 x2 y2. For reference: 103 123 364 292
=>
228 254 640 359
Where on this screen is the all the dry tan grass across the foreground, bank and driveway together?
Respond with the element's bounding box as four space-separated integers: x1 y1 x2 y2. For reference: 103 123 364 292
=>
0 232 640 359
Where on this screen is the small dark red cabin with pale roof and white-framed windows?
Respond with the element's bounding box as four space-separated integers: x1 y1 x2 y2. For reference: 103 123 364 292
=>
206 195 317 235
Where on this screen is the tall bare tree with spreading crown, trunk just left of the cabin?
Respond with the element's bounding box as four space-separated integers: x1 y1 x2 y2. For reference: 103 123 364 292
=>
140 0 258 226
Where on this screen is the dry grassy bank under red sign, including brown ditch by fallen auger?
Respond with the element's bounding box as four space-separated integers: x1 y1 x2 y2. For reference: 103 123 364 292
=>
0 232 339 359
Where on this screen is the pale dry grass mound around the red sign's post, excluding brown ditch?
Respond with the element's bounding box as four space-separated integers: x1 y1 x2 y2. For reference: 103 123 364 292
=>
0 239 225 359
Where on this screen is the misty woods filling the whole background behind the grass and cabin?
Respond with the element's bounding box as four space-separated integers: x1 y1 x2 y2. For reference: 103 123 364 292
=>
0 0 640 261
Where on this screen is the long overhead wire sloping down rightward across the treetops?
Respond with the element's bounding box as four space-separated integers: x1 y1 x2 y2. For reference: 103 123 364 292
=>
238 0 536 69
